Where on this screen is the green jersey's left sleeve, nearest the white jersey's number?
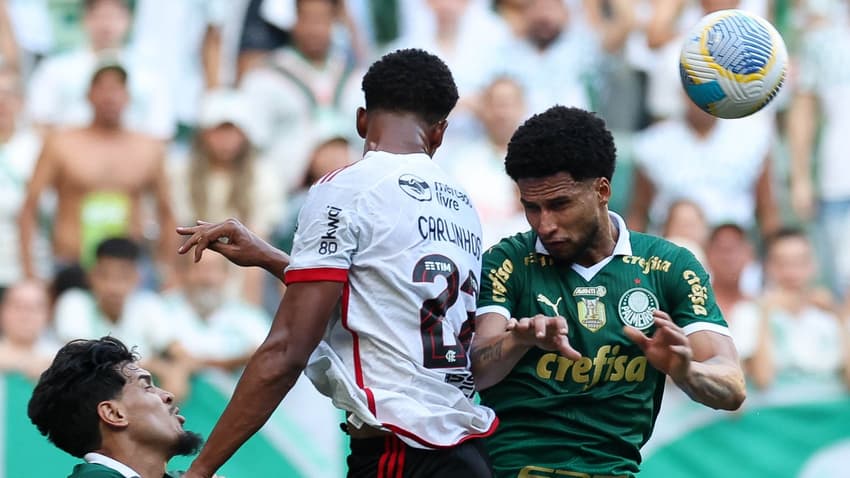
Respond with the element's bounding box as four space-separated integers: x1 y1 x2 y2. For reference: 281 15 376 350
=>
476 240 523 319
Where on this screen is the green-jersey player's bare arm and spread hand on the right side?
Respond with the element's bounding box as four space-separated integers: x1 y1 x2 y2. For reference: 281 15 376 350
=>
625 310 747 410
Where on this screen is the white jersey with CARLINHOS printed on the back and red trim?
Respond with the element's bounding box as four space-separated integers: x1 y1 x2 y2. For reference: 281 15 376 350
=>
286 152 497 448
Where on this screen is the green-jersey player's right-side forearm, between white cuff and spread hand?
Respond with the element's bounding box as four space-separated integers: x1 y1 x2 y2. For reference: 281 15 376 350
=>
676 357 747 410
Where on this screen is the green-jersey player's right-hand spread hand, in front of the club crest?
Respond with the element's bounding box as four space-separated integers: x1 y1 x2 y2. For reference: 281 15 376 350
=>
624 310 693 383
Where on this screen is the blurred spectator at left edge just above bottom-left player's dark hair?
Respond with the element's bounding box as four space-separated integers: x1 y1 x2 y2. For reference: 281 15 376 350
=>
0 281 59 379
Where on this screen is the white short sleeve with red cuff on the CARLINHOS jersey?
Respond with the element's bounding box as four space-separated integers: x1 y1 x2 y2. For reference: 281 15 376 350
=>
285 183 360 284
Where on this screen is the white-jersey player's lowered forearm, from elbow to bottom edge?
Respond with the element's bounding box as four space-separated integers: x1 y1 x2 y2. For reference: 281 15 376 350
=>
192 344 303 476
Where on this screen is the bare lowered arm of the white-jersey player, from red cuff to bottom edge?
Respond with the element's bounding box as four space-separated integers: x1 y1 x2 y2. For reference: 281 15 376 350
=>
185 282 343 478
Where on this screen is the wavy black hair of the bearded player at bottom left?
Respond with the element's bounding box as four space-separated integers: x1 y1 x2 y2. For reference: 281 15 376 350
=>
27 336 139 458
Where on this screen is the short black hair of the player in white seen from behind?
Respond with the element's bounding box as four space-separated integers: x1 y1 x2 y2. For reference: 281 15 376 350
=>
363 49 458 124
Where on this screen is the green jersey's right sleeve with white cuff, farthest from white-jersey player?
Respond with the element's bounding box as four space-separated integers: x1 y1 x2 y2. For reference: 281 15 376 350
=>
665 247 730 335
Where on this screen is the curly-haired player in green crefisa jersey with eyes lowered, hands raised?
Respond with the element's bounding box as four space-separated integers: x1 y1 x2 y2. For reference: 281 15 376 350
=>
472 106 745 478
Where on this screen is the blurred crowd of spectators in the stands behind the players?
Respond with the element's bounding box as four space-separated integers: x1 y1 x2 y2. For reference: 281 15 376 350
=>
0 0 850 404
